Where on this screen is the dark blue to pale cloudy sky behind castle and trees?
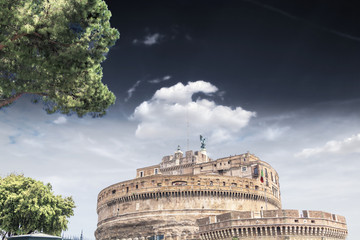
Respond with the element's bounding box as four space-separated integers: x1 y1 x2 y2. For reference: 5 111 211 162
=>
0 0 360 240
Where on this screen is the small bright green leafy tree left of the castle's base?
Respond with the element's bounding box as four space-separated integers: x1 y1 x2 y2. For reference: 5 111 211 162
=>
0 174 75 239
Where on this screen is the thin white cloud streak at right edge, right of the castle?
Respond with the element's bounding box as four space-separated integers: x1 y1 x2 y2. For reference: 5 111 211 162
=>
295 133 360 157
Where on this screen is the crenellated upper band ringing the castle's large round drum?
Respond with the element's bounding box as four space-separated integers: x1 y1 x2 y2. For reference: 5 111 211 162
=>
98 172 281 214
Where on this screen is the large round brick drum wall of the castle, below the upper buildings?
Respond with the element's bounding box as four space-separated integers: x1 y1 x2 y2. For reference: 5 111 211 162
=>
95 175 281 240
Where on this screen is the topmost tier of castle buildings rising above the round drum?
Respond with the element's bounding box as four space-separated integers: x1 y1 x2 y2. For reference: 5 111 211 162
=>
136 150 280 197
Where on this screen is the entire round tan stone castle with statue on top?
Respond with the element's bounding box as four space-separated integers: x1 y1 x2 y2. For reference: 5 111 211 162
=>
95 144 347 240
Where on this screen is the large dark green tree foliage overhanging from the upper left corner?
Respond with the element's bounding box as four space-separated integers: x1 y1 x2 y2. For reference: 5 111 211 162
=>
0 0 119 116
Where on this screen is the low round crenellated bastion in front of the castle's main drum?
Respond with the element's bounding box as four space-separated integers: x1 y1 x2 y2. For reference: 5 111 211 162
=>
197 209 347 240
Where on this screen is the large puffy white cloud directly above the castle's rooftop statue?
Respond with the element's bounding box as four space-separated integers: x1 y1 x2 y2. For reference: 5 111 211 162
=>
131 81 255 142
